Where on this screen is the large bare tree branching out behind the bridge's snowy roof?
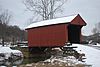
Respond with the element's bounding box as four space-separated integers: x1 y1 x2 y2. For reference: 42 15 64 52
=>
23 0 67 20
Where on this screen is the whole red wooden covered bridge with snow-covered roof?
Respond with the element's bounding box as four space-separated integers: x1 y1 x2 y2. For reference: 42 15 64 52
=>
26 14 86 47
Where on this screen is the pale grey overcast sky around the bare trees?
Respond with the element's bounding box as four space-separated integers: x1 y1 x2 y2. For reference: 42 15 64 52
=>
0 0 100 35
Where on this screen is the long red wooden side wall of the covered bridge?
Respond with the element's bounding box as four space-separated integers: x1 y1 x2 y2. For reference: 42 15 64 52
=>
28 24 68 47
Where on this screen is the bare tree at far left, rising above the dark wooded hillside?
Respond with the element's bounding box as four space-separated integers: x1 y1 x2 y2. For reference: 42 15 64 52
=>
0 10 12 46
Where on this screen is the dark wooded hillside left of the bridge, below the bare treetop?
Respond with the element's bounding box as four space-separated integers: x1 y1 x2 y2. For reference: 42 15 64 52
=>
0 23 27 45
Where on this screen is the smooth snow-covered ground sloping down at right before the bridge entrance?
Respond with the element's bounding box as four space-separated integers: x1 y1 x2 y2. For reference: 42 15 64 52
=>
73 44 100 67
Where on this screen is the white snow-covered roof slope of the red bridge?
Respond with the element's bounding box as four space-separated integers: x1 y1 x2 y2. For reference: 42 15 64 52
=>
25 14 78 29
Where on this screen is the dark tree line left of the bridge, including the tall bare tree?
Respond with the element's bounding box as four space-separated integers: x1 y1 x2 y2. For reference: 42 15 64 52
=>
0 10 26 46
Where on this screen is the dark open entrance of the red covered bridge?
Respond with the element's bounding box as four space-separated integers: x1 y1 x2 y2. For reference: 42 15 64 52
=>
68 24 82 43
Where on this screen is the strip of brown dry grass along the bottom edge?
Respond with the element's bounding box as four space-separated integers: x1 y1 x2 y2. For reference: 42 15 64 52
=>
19 63 85 67
